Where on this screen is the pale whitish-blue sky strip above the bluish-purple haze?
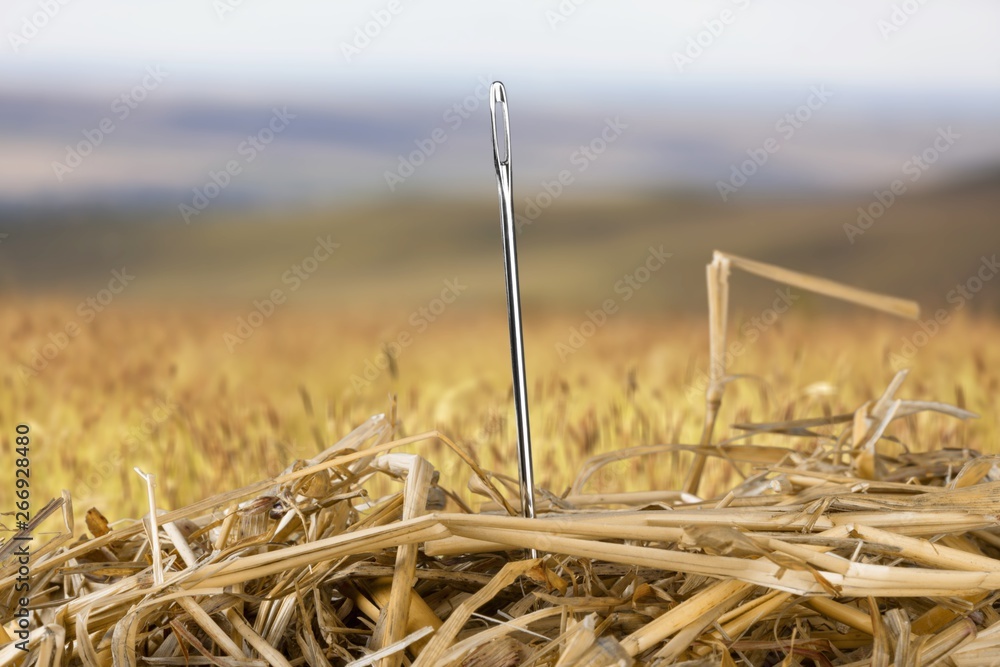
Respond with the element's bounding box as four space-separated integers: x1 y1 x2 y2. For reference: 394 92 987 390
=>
0 0 1000 99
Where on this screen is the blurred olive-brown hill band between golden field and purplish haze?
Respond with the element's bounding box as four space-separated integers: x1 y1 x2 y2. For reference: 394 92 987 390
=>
0 171 1000 320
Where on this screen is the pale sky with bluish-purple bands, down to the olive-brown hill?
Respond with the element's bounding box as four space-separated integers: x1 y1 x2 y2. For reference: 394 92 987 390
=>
0 0 1000 209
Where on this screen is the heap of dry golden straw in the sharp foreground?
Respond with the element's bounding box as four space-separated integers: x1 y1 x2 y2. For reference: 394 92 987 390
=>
0 256 1000 667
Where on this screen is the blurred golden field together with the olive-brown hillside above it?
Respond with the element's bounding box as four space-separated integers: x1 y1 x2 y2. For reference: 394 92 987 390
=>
0 183 1000 518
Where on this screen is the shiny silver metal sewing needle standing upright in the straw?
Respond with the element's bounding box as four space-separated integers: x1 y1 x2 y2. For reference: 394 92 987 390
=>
490 81 538 558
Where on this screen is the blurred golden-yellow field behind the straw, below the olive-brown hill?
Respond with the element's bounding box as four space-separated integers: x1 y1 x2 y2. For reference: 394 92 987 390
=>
0 299 1000 521
